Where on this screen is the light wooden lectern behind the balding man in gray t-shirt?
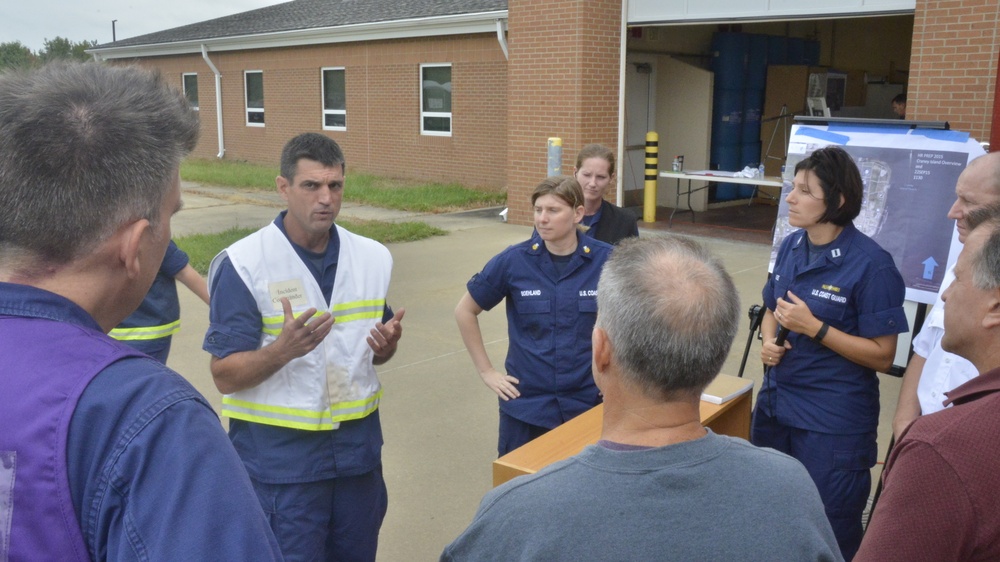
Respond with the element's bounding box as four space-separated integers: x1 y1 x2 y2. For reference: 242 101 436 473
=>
493 392 752 486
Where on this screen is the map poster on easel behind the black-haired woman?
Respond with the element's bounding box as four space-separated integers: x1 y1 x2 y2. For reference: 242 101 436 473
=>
768 122 985 304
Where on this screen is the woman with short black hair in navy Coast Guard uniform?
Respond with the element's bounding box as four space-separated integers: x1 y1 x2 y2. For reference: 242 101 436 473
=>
750 147 907 560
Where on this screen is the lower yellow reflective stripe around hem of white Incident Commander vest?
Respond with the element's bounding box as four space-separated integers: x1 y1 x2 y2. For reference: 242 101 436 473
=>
222 389 382 431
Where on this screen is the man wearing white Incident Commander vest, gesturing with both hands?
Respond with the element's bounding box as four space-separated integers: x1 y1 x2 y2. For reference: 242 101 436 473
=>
203 133 404 560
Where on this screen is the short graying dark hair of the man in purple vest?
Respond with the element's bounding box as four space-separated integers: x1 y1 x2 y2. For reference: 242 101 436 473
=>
0 62 199 264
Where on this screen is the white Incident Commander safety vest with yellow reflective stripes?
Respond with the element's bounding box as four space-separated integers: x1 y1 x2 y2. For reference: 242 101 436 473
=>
209 223 392 431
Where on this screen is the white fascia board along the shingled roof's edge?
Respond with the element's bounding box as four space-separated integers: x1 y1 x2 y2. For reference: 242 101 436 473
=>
86 10 507 60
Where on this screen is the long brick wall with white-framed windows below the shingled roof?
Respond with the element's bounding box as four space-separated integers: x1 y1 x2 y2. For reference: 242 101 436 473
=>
128 34 507 188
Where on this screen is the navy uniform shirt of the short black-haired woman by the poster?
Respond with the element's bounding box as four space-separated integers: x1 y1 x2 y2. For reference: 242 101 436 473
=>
757 224 908 435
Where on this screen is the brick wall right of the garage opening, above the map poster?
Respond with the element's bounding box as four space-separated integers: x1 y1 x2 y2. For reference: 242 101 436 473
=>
906 0 1000 141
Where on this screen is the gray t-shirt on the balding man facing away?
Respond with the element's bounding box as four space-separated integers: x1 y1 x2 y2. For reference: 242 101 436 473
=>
441 430 841 562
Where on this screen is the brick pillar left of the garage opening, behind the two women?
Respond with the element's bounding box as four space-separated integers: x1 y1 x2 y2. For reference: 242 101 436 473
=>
507 0 622 224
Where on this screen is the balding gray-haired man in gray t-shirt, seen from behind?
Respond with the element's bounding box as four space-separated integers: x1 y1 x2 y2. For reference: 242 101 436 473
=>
441 236 841 562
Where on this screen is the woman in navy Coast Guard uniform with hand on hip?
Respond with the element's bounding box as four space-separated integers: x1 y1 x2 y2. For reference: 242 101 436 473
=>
455 176 611 456
